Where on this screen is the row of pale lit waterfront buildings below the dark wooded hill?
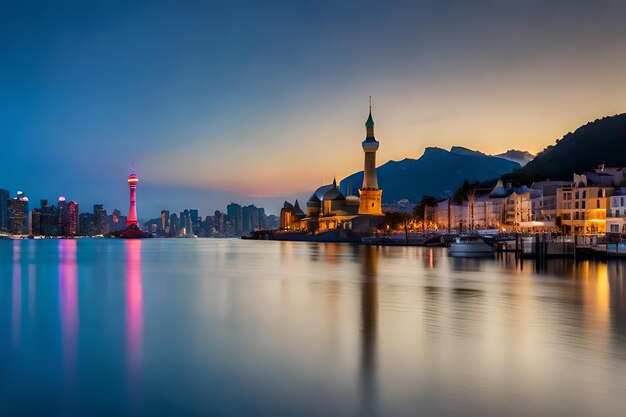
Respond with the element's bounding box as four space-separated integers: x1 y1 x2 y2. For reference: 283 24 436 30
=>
432 166 626 235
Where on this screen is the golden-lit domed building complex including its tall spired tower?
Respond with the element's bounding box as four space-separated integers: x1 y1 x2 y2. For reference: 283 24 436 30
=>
280 98 384 233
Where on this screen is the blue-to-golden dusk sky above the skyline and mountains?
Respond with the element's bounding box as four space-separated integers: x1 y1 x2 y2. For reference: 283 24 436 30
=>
0 0 626 214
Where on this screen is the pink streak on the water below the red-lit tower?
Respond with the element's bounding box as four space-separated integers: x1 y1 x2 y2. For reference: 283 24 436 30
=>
125 239 143 394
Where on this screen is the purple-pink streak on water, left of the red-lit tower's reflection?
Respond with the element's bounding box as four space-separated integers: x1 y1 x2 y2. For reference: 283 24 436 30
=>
59 239 78 384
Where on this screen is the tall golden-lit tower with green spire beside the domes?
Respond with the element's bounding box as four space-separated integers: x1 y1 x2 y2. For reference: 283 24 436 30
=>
359 97 383 216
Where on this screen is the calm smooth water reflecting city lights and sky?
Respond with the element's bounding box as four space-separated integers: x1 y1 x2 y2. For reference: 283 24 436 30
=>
0 239 626 416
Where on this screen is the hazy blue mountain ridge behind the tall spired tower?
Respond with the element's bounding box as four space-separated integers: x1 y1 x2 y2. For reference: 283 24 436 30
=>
339 146 524 203
